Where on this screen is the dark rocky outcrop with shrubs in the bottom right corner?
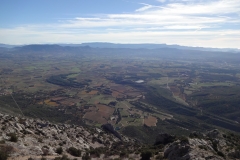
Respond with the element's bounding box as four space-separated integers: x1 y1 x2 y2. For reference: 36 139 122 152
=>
164 129 240 160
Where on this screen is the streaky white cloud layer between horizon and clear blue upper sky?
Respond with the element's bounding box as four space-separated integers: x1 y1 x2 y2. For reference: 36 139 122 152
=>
0 0 240 48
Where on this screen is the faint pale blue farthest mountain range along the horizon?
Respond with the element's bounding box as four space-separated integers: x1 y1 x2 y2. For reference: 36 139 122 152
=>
0 42 240 53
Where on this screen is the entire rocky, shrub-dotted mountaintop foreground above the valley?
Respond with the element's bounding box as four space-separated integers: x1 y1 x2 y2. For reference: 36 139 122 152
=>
0 113 240 160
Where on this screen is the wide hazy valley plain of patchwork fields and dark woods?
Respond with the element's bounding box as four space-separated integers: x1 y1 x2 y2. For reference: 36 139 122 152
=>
0 45 240 159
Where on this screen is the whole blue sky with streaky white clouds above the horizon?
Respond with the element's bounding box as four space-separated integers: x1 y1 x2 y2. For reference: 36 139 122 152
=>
0 0 240 48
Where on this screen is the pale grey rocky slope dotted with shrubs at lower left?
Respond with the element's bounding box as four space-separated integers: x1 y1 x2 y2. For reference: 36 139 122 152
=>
0 113 140 159
